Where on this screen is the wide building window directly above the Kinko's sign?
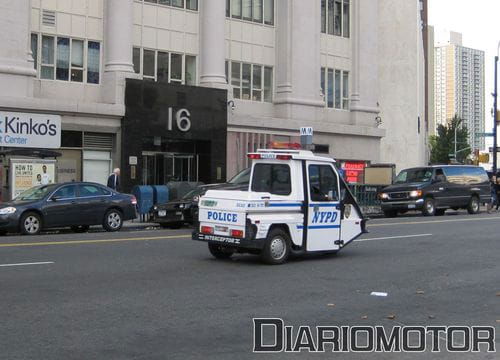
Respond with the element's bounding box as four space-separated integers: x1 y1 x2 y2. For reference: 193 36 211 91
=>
31 34 101 84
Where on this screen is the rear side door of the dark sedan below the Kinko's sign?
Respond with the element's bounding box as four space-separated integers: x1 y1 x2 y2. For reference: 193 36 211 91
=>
78 184 111 225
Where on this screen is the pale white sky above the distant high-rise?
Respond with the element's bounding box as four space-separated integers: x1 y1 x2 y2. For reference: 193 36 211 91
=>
429 0 500 147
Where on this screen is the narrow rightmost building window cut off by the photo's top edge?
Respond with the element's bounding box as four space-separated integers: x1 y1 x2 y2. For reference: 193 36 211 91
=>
321 0 351 37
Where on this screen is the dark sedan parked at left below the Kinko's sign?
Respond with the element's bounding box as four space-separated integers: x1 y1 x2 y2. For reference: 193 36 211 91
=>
0 182 137 235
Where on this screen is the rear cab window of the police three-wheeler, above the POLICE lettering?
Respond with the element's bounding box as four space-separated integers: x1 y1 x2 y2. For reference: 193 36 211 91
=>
252 164 292 195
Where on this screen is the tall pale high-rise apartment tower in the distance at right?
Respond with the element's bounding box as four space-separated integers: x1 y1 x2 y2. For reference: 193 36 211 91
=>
434 33 485 150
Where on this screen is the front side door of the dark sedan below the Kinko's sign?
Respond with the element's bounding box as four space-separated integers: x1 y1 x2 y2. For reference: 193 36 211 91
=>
42 184 81 227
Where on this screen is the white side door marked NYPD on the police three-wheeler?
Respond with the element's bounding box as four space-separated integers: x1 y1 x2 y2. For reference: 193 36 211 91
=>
306 162 341 251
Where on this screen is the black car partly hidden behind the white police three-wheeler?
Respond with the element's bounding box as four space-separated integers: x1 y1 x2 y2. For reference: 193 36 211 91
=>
152 168 250 229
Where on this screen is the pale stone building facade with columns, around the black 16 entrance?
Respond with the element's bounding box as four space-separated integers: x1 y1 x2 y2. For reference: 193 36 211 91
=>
0 0 428 197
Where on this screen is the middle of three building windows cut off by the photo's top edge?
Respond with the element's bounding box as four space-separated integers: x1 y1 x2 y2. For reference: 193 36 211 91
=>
226 0 274 25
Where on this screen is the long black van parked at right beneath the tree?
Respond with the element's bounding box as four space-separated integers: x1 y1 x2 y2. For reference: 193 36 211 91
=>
379 165 490 217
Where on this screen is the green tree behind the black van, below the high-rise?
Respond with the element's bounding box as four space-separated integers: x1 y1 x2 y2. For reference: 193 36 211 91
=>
429 115 471 164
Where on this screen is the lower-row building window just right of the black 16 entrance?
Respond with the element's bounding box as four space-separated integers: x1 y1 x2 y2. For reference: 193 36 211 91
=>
226 61 273 102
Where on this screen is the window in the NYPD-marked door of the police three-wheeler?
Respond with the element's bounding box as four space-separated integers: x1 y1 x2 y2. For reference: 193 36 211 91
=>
309 165 339 201
